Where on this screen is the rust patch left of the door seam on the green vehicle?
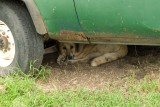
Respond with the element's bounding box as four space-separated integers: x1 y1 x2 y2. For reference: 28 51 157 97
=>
56 31 87 41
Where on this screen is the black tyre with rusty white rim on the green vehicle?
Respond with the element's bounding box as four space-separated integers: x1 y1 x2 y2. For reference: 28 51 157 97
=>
0 0 44 76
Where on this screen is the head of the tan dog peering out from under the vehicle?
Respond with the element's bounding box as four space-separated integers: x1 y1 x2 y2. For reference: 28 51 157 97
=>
59 43 76 60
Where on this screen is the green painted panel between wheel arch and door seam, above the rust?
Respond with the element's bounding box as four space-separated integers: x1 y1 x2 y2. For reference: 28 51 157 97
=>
35 0 80 36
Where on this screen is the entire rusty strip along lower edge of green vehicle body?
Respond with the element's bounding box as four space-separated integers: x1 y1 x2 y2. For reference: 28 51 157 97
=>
50 31 160 45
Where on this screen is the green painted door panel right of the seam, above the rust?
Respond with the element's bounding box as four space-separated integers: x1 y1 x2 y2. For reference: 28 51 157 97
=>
75 0 160 38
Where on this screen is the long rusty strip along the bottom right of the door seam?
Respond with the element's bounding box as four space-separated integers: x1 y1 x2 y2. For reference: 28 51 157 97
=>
89 34 160 45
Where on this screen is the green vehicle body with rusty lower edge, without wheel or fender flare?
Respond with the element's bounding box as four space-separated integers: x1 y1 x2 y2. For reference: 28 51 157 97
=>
28 0 160 45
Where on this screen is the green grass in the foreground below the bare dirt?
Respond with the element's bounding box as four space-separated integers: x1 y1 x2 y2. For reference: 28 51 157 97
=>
0 70 160 107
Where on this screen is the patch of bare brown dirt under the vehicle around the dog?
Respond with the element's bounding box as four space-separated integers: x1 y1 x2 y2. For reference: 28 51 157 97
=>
37 46 160 90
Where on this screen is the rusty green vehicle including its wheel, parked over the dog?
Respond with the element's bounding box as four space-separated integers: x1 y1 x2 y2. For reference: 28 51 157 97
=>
0 0 160 75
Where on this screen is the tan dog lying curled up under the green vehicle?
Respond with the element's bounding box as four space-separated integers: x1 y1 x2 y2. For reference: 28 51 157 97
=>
57 43 128 66
